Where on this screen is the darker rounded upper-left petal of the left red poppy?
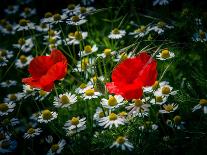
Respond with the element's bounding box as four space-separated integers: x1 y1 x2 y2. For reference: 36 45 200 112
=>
29 56 54 79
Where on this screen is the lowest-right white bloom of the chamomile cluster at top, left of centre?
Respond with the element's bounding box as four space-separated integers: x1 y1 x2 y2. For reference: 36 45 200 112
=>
66 15 87 26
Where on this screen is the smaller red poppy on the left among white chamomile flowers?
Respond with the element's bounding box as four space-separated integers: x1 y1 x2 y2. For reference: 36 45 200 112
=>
22 50 67 91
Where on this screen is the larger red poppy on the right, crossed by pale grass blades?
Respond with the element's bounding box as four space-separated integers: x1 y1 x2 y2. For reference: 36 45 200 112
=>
106 52 157 100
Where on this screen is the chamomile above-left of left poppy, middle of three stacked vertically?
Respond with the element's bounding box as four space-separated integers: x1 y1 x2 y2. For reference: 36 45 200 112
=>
13 38 34 53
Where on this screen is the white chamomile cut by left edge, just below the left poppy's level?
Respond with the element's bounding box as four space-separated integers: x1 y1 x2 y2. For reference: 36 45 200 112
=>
0 102 16 116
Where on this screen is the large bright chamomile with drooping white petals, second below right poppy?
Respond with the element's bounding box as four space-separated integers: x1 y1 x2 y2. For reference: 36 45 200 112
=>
98 113 125 129
